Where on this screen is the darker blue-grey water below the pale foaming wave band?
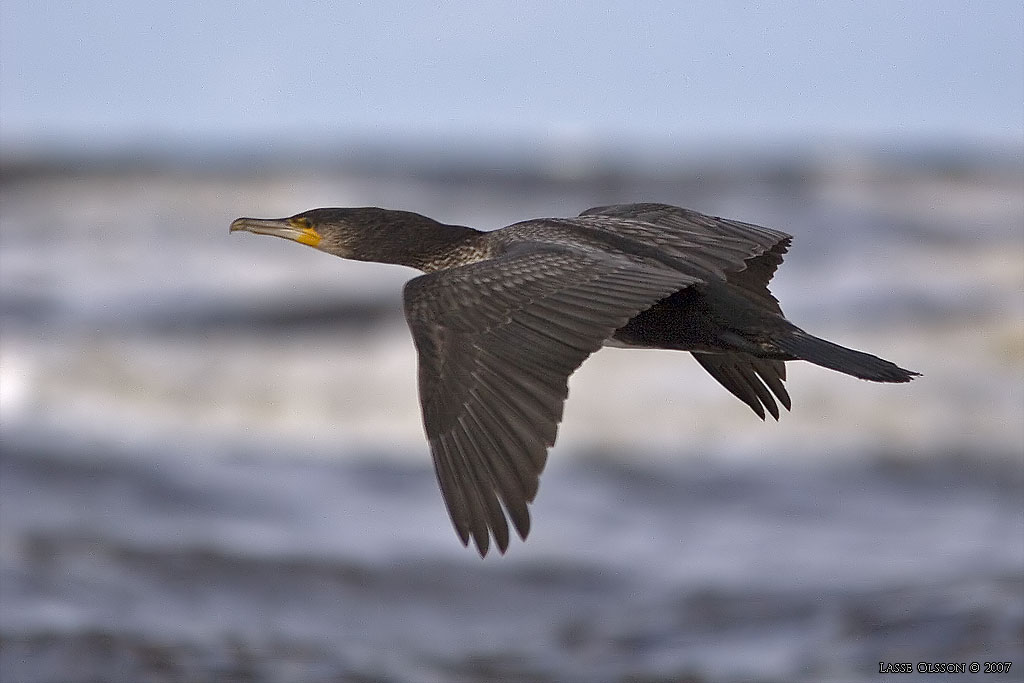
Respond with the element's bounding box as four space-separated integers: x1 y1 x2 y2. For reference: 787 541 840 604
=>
0 439 1024 683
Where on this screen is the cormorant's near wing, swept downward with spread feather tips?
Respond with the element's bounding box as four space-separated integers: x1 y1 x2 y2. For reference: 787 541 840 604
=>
404 243 694 555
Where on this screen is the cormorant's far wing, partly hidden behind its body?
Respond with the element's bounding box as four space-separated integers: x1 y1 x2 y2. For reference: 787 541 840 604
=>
580 204 793 420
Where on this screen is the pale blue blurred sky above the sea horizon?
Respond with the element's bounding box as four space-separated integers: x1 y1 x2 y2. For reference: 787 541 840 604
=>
0 0 1024 151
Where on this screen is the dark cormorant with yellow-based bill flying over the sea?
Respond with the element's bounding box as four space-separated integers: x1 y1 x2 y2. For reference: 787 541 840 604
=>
230 204 918 556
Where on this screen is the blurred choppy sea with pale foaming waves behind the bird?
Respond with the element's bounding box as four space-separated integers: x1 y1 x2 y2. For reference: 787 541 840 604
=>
0 150 1024 681
